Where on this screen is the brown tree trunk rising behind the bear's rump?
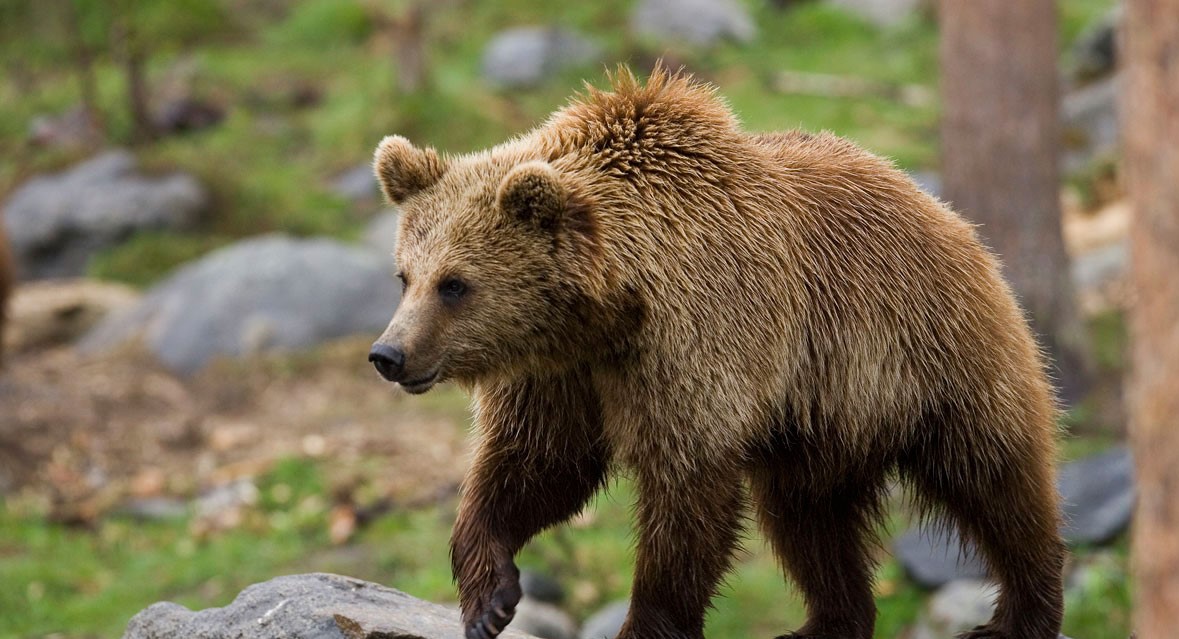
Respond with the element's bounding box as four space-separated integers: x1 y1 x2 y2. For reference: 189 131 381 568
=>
938 0 1088 403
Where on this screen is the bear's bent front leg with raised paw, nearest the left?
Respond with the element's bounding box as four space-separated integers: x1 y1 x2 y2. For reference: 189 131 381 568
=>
450 373 608 639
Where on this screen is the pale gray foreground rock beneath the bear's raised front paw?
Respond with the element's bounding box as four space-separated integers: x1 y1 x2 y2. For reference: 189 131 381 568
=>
123 573 539 639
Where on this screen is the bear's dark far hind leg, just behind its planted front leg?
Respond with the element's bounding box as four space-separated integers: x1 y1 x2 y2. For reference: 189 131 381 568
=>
751 459 883 639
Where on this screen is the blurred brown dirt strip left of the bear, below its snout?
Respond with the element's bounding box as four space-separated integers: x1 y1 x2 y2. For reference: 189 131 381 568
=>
0 338 468 523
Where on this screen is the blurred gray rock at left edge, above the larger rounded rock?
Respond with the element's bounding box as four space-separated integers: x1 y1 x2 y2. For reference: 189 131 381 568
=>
4 151 209 279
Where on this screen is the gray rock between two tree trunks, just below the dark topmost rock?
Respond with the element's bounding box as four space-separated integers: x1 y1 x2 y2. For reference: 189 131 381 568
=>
1060 75 1121 173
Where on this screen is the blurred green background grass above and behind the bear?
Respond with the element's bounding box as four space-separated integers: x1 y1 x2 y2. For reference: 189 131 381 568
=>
0 0 1112 284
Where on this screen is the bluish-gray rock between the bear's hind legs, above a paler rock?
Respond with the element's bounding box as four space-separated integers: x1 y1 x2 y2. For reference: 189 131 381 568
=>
894 527 987 588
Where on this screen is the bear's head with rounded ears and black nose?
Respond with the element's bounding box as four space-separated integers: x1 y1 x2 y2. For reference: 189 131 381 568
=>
369 136 600 393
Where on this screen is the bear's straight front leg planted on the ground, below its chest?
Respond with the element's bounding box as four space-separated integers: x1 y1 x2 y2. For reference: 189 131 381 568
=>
618 463 745 639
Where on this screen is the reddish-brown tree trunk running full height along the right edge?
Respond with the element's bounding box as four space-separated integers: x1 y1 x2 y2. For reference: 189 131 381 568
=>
1121 0 1179 639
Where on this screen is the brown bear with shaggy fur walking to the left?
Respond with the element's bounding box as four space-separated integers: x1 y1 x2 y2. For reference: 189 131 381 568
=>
369 70 1065 639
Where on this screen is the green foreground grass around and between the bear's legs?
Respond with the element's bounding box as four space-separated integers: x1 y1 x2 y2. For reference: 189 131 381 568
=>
0 444 1131 639
